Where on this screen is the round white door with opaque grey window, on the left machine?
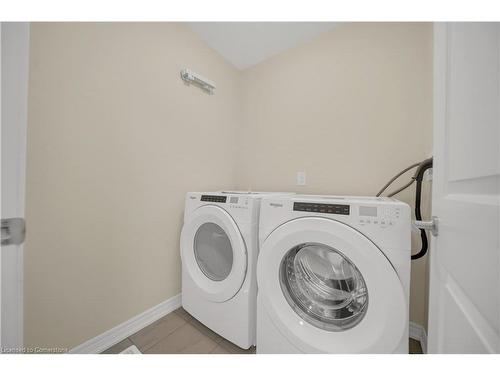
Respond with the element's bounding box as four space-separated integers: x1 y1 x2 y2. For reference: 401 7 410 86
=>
181 205 247 302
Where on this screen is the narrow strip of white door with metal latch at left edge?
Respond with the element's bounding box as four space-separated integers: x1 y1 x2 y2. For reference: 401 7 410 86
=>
0 23 29 350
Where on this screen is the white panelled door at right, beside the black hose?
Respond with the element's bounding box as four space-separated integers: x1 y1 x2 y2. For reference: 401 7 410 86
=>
428 23 500 353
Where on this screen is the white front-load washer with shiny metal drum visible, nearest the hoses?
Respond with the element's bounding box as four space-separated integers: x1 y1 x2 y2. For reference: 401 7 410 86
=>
257 195 411 353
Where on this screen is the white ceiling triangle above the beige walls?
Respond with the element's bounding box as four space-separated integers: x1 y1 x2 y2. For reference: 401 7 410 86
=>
188 22 339 70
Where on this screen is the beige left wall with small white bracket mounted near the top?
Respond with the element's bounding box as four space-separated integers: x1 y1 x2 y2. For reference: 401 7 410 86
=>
25 23 239 348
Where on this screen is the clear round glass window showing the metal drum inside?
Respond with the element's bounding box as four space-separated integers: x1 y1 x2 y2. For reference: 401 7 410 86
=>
280 243 368 331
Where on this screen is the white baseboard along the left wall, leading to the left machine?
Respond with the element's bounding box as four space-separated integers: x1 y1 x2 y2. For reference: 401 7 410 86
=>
69 294 181 354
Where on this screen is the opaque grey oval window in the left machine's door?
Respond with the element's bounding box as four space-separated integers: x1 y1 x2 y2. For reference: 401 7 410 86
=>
194 223 233 281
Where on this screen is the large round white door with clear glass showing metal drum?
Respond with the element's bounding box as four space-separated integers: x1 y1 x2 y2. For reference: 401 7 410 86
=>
257 217 408 353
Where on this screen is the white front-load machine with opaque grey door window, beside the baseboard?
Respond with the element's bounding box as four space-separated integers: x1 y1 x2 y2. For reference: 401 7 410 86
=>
180 192 292 349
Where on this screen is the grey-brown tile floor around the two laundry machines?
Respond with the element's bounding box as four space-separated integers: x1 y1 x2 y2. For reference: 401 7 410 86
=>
103 307 422 354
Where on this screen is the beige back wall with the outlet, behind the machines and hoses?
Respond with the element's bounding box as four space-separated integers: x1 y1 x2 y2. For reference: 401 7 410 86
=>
237 23 432 326
